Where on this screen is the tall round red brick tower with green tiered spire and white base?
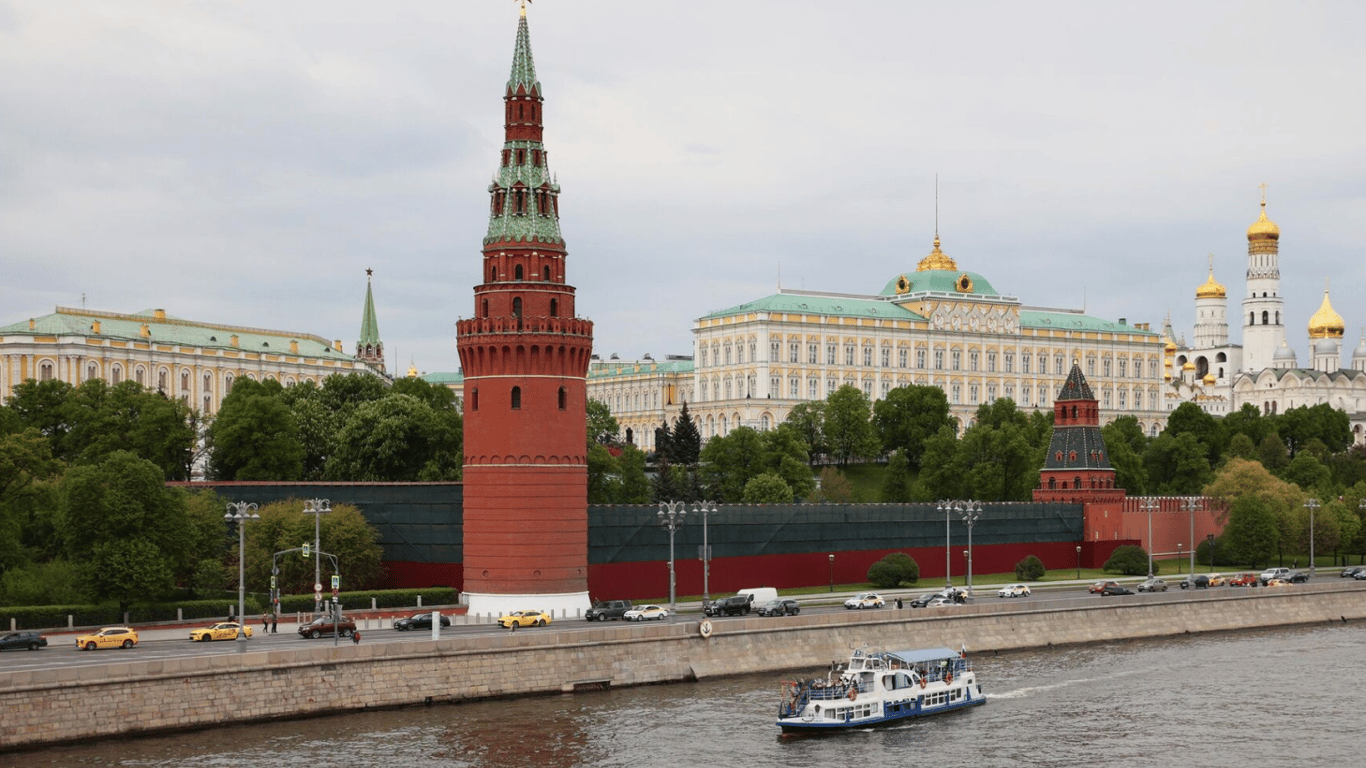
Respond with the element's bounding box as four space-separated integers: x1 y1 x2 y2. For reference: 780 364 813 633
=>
456 7 593 614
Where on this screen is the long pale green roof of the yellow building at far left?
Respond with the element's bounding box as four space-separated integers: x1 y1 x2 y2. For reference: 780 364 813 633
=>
0 306 355 361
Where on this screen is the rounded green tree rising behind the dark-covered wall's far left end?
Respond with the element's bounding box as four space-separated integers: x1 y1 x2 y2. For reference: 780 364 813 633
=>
209 376 303 480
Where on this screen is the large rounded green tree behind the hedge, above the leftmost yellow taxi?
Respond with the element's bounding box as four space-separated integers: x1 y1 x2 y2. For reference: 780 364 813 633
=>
61 451 191 611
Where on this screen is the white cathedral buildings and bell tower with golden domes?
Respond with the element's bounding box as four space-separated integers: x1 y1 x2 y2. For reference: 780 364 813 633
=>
1162 198 1366 443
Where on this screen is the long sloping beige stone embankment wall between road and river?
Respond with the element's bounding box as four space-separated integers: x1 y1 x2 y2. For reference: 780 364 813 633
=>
0 584 1366 750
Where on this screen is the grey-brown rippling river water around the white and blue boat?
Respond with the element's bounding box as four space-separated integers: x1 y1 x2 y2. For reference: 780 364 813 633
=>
13 625 1366 768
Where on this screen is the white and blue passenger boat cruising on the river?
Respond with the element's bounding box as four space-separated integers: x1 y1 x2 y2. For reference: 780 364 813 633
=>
777 648 986 734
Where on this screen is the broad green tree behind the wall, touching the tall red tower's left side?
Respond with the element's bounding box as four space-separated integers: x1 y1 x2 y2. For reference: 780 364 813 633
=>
325 394 462 482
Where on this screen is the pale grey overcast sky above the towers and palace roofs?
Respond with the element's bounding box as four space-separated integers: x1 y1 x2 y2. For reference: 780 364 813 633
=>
0 0 1366 373
